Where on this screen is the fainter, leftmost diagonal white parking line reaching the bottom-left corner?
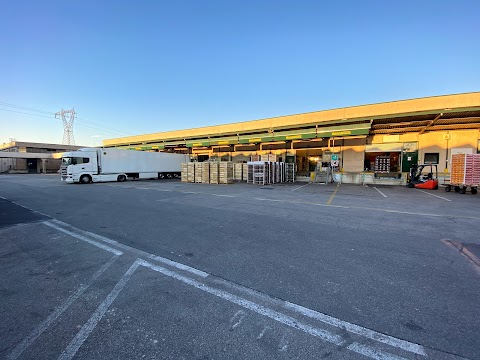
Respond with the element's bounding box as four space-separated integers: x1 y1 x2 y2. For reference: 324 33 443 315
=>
7 255 118 360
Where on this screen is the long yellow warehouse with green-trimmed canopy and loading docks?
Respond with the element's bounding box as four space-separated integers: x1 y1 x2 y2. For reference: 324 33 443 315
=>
103 92 480 184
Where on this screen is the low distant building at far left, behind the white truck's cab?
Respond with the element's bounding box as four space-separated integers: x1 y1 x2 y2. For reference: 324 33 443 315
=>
0 141 84 174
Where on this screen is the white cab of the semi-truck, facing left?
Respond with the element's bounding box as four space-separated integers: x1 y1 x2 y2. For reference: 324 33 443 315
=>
60 149 98 184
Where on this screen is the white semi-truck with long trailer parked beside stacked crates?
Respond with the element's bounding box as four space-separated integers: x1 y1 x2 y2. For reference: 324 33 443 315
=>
60 148 190 184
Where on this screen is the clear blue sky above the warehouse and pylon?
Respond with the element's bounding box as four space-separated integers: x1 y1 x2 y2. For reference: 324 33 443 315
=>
0 0 480 146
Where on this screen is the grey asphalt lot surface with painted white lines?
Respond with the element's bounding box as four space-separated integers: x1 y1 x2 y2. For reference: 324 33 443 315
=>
0 175 480 359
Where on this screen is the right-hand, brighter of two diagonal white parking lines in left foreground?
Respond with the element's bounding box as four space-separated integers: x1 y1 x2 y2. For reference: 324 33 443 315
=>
58 261 140 360
